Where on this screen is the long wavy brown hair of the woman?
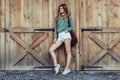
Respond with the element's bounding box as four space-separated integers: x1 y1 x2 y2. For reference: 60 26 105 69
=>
55 3 70 21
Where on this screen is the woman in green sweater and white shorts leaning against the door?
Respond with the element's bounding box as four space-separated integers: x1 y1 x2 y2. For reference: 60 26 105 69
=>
49 4 73 75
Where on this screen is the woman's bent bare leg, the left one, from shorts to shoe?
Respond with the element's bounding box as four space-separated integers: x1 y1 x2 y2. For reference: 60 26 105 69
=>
49 40 62 66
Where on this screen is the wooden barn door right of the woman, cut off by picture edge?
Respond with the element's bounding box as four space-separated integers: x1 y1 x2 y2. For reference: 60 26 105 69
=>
81 0 120 70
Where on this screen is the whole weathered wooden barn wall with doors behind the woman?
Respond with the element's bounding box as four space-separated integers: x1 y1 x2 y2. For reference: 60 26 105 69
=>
0 0 120 70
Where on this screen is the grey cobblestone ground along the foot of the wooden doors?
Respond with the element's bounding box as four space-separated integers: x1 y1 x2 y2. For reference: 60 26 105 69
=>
0 70 120 80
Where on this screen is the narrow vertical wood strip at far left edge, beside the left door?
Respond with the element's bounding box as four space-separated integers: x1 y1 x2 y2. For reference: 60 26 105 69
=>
0 0 5 70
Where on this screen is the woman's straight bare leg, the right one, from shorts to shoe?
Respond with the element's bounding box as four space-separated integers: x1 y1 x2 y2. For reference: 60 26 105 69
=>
64 39 72 69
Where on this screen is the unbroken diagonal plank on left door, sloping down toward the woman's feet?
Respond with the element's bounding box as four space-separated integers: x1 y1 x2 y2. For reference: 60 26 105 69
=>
10 33 48 65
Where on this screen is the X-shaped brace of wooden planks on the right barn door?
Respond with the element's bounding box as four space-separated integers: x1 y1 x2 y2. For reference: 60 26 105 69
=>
87 32 120 65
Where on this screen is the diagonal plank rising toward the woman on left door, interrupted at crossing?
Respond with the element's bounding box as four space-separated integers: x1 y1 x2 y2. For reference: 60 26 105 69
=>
13 33 48 65
